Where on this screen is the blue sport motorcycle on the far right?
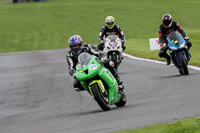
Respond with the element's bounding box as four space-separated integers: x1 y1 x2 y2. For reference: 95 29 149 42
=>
167 31 190 75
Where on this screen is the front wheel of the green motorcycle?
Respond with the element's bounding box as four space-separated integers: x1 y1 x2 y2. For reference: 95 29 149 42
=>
91 83 110 111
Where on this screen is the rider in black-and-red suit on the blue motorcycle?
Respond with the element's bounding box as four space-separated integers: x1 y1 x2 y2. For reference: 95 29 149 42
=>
158 14 192 65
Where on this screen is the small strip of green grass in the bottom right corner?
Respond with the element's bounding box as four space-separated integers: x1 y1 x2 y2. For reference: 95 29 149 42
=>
115 118 200 133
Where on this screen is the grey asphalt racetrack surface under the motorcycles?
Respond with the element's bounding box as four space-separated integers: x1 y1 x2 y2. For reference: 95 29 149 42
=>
0 49 200 133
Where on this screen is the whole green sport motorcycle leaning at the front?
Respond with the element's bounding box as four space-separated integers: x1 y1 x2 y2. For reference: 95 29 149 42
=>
76 52 127 111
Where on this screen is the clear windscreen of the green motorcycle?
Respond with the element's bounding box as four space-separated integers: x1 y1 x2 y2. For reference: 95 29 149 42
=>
78 52 92 68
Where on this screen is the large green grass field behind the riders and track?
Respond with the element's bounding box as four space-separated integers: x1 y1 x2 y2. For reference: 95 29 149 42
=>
0 0 200 66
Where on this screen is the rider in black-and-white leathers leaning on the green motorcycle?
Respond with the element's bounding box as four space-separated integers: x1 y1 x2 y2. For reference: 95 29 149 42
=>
66 35 123 91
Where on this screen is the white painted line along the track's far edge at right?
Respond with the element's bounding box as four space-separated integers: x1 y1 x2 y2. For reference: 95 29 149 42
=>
123 53 200 71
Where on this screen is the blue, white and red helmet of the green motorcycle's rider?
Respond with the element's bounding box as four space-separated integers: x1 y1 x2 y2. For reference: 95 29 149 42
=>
68 35 83 54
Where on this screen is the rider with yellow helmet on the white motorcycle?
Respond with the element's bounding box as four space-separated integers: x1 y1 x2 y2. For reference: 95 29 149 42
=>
97 16 126 51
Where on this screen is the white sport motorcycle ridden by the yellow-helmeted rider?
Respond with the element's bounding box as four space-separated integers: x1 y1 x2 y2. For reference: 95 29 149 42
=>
103 35 123 70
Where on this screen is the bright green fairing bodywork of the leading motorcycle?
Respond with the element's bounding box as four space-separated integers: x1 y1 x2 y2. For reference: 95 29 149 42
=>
76 53 121 104
